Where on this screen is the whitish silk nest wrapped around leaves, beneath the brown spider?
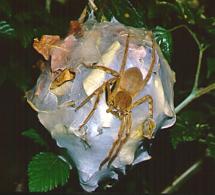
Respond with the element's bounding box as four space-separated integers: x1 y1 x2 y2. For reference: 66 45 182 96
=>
26 18 176 192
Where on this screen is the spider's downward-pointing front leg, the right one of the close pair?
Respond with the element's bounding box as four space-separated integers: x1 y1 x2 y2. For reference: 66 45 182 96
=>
107 114 132 167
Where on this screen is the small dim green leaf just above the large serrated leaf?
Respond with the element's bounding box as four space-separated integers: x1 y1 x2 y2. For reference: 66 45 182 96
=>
22 129 47 146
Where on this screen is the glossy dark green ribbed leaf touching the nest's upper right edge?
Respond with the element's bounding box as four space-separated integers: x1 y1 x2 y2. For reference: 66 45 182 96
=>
153 26 172 62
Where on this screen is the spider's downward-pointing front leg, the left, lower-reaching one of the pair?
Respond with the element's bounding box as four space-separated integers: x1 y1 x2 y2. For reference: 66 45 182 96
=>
99 118 125 170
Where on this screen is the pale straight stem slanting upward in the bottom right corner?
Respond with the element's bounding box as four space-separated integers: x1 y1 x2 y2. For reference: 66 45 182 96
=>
161 159 203 194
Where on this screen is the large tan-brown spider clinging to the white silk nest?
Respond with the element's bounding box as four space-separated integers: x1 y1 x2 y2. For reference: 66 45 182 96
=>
76 33 156 169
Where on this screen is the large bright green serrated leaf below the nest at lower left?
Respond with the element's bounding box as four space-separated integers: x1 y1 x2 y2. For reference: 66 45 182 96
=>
28 152 70 192
